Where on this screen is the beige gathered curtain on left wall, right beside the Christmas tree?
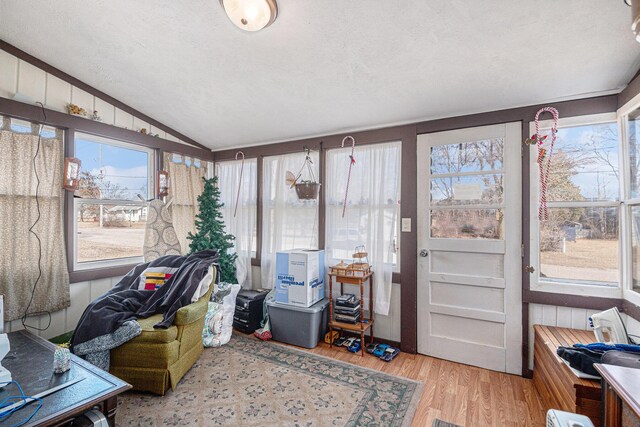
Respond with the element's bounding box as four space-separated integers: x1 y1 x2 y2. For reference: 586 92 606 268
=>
165 154 207 254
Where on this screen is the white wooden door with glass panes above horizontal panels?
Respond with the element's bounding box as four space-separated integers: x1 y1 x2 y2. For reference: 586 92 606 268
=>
417 123 522 374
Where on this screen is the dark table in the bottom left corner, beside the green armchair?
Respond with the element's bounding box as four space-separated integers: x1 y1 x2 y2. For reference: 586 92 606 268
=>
0 330 131 426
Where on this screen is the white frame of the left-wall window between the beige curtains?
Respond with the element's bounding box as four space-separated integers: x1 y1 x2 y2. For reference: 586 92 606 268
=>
72 132 157 271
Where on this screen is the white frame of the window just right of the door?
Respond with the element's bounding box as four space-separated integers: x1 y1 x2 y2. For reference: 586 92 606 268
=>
529 113 628 298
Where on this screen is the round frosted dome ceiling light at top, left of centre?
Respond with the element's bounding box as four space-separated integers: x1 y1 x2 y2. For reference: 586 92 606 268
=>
220 0 278 31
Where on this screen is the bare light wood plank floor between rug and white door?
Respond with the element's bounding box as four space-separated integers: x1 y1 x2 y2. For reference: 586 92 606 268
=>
290 343 545 427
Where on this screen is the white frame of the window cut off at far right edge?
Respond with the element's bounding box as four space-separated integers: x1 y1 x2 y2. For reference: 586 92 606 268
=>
617 94 640 306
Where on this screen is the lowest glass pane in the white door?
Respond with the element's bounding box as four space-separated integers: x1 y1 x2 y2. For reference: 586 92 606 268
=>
431 209 504 239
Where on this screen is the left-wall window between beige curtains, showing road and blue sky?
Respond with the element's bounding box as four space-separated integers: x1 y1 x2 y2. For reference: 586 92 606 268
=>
73 133 155 270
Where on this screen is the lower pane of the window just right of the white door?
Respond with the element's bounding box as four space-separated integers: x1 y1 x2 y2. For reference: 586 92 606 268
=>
540 207 619 283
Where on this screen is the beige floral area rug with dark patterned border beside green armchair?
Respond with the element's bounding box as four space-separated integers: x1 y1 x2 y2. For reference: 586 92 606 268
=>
116 335 422 426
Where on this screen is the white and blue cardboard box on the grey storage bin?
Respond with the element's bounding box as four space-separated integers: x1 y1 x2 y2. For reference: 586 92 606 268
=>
276 249 324 307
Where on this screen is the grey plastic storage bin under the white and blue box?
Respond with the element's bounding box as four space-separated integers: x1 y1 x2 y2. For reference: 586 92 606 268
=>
267 298 329 348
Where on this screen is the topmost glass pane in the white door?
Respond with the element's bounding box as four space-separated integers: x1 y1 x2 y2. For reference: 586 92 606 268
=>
431 138 504 175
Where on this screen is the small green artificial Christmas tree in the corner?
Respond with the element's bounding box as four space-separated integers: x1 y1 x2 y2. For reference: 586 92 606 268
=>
187 176 238 283
